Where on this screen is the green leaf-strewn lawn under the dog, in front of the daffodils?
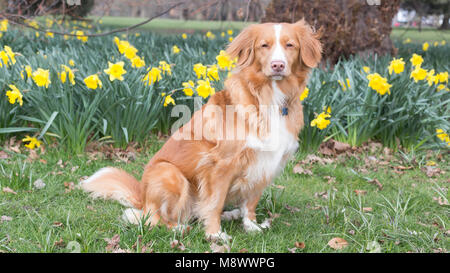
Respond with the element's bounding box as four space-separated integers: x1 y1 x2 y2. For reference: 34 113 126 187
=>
0 140 450 252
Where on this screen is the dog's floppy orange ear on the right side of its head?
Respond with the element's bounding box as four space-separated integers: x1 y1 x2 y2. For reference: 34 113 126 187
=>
295 19 322 68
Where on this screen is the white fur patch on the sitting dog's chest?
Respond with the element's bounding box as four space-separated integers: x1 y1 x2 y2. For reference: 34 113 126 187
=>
246 81 298 183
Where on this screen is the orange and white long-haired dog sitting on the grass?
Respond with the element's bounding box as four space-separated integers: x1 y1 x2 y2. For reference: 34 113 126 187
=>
81 20 322 241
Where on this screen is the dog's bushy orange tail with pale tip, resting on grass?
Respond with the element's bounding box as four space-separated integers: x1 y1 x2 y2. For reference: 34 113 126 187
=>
80 167 143 210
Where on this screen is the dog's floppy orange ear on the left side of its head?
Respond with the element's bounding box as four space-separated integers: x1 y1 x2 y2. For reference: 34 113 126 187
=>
226 26 256 67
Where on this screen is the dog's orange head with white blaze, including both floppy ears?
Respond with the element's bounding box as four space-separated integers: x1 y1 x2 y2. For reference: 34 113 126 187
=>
227 20 322 80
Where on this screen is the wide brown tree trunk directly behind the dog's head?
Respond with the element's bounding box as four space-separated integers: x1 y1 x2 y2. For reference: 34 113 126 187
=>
262 0 400 63
